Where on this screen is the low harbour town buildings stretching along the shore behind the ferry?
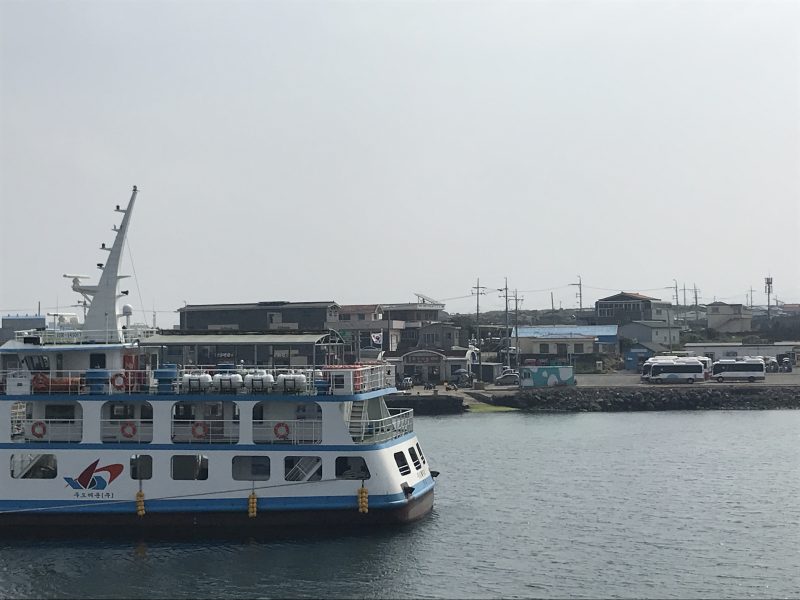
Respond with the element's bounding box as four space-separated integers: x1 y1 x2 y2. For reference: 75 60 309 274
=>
0 292 800 384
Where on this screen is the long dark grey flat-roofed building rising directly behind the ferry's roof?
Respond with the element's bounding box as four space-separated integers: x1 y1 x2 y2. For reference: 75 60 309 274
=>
178 300 339 331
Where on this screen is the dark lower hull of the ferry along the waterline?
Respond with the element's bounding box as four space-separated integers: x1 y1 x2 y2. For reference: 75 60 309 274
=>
0 488 434 540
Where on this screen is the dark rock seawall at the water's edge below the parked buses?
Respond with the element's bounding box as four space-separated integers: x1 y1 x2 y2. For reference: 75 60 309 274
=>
492 384 800 412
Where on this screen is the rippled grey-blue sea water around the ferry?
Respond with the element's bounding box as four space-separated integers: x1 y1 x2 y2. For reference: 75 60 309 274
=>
0 411 800 598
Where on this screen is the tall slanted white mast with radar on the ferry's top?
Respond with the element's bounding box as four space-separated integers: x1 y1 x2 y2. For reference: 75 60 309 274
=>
72 186 138 343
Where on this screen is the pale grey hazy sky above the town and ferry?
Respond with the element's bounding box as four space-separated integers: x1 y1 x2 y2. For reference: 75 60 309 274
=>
0 0 800 325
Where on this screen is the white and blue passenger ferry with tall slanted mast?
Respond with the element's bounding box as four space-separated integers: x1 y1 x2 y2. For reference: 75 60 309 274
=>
0 186 438 537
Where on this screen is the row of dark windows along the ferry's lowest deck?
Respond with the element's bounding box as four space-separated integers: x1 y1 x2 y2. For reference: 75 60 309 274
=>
11 444 427 481
